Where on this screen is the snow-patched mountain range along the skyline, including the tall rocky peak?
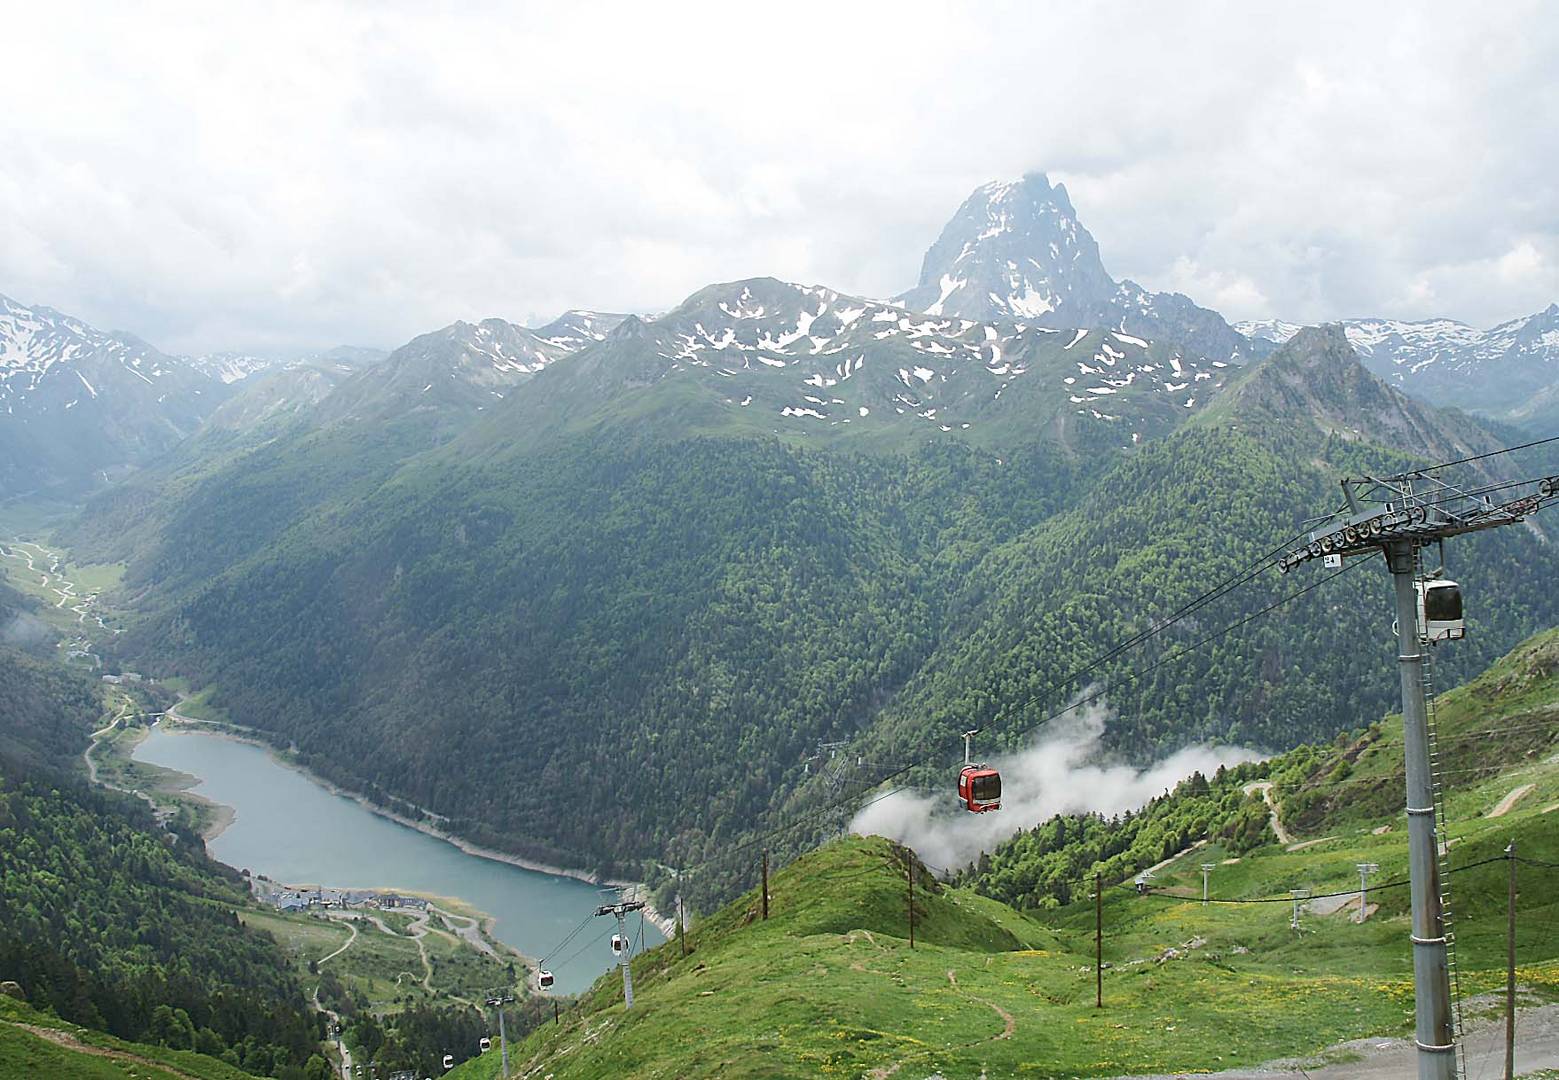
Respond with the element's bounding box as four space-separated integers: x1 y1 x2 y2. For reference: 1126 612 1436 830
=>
0 173 1559 497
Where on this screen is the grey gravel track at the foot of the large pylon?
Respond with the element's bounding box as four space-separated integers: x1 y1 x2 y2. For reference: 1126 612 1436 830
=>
1118 1005 1559 1080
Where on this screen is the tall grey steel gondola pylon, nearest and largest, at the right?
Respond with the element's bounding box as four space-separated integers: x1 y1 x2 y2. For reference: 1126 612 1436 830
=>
1277 469 1559 1080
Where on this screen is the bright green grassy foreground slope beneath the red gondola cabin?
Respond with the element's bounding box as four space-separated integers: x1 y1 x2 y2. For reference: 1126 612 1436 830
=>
451 631 1559 1080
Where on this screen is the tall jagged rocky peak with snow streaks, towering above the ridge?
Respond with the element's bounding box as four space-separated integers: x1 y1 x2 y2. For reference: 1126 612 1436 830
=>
898 173 1252 363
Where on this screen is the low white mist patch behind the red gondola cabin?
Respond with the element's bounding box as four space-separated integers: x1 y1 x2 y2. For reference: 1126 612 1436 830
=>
850 698 1263 870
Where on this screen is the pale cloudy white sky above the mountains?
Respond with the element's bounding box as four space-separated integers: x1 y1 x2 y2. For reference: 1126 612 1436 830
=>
0 0 1559 352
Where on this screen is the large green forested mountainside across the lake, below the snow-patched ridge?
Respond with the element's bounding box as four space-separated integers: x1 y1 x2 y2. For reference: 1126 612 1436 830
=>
51 321 1559 903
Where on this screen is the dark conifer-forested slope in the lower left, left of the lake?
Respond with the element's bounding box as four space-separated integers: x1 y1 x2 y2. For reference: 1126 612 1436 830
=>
0 653 320 1077
